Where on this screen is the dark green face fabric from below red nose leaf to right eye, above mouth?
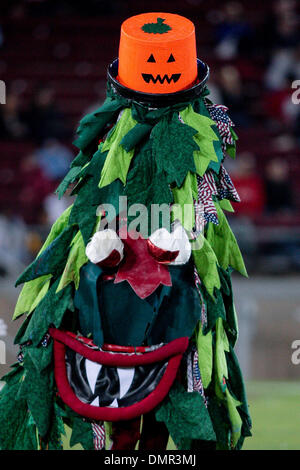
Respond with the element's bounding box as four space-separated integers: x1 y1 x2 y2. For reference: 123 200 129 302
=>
99 264 201 346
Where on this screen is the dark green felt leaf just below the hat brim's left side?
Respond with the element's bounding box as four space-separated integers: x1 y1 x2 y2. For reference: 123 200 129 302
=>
74 97 127 152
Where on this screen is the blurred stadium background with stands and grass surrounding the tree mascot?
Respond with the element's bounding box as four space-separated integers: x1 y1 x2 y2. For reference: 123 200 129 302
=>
0 0 300 449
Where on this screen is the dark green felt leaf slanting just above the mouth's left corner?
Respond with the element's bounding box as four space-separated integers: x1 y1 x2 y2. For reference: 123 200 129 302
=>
20 279 73 346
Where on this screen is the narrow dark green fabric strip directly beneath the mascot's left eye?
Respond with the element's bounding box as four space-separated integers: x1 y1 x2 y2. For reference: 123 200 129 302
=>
74 263 103 347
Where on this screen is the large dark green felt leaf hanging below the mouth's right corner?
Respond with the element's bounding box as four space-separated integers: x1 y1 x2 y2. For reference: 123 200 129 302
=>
156 382 216 450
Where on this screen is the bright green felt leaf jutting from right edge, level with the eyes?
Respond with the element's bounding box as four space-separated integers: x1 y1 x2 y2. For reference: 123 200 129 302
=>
207 201 247 277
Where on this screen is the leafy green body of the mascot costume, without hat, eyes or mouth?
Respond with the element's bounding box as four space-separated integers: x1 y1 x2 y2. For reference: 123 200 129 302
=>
0 80 251 449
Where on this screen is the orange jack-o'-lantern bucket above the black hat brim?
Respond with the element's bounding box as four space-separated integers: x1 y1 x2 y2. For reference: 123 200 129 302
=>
117 13 197 93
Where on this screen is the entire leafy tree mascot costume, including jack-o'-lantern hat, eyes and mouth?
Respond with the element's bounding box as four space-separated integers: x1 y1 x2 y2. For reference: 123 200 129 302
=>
0 13 251 450
